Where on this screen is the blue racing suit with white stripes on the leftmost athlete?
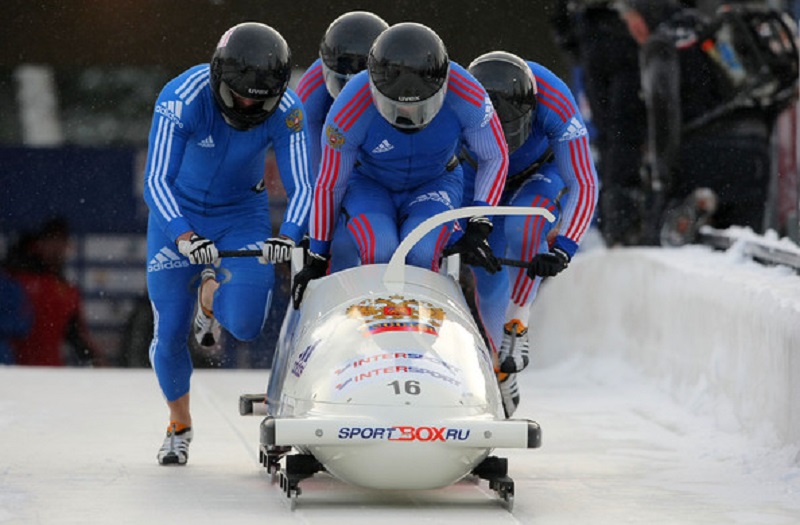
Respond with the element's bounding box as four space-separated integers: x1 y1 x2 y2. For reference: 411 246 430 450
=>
144 64 311 401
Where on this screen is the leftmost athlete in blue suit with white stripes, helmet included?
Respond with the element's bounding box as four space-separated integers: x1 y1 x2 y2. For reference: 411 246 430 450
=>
144 23 311 464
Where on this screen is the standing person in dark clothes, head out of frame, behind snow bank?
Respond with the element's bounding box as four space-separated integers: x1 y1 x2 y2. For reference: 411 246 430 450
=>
553 0 646 246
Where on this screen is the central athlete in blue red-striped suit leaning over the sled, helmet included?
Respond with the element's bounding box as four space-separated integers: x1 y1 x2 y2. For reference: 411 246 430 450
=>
292 22 508 308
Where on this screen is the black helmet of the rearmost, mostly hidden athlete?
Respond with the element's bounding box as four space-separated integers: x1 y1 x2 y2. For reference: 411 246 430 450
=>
319 11 389 98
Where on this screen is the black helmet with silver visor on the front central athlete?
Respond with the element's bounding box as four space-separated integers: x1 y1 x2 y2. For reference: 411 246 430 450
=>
367 22 450 131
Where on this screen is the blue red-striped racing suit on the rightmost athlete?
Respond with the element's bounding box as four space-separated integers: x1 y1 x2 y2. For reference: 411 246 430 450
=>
462 61 597 349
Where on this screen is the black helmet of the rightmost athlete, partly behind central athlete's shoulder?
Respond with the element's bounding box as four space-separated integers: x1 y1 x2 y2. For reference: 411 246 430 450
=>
467 51 538 153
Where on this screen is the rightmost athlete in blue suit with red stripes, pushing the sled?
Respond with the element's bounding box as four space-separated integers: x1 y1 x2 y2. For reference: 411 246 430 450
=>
462 51 597 416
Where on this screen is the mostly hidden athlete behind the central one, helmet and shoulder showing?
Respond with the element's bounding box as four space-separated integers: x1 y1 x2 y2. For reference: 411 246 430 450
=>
297 11 389 272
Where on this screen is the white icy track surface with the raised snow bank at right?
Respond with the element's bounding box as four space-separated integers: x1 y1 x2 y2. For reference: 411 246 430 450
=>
0 238 800 525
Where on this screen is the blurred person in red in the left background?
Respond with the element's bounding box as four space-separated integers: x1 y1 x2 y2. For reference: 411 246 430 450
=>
7 217 103 366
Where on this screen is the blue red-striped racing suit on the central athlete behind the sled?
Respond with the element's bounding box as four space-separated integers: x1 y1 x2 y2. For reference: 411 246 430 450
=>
309 62 508 271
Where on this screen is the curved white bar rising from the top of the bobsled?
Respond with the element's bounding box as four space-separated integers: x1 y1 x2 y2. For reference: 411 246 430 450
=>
383 206 556 284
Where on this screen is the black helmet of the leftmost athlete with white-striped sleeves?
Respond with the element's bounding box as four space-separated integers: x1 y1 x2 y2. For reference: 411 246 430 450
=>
211 22 291 130
